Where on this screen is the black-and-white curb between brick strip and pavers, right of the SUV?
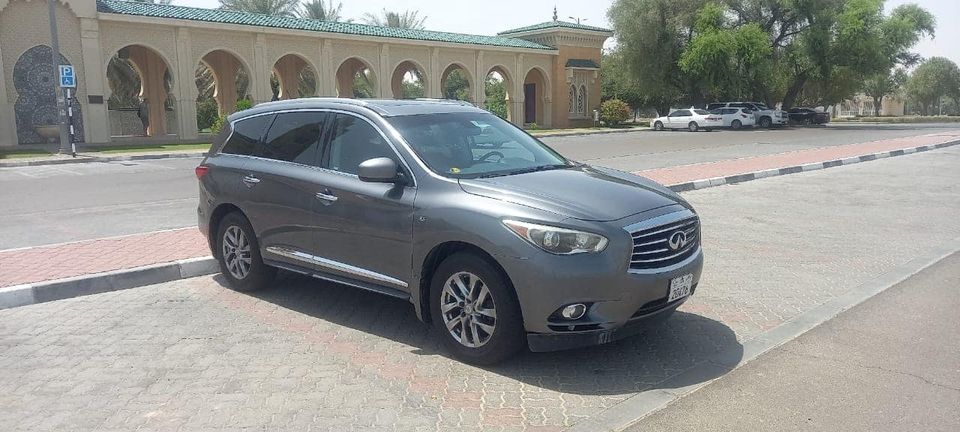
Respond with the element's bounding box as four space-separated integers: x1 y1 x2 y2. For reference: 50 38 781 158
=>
664 140 960 192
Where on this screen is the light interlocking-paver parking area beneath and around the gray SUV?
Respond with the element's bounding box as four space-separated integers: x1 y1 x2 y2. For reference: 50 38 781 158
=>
0 147 960 431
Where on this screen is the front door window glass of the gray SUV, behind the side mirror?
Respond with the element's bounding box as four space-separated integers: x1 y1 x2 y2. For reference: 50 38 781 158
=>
326 114 397 174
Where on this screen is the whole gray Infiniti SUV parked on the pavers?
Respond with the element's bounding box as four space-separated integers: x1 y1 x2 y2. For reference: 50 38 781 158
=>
197 99 703 364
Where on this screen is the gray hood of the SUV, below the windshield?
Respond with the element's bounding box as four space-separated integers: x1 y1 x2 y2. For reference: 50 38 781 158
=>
460 165 690 221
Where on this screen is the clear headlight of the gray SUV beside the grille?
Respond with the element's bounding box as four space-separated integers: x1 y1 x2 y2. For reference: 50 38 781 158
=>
503 219 607 255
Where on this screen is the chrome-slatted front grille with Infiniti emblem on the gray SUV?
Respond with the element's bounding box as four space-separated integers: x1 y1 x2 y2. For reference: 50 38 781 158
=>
630 216 700 270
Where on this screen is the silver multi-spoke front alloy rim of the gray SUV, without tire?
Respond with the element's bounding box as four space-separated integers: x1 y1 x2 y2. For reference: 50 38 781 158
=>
440 272 497 348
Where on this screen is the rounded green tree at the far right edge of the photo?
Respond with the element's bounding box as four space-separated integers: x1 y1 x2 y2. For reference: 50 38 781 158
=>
906 57 960 115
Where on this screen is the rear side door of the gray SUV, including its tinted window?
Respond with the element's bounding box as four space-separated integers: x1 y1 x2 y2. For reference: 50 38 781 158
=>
240 111 327 267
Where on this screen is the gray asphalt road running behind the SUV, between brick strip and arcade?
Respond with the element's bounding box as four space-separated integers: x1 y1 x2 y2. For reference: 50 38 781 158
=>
0 125 960 249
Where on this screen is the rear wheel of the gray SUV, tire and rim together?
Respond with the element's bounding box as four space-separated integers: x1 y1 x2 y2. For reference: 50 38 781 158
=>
217 212 277 292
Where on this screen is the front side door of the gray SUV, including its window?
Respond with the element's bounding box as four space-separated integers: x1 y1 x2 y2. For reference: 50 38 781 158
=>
317 113 416 291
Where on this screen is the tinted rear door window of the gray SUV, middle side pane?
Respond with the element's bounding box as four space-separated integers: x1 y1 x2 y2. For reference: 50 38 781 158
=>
262 111 326 165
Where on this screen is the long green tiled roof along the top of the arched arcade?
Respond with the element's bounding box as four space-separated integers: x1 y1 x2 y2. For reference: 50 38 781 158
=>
97 0 553 50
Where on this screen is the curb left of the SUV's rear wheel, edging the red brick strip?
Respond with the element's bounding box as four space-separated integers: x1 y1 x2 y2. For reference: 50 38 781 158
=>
0 256 220 310
